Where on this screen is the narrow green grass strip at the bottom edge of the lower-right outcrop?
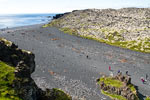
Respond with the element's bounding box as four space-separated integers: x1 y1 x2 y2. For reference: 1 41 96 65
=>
101 90 127 100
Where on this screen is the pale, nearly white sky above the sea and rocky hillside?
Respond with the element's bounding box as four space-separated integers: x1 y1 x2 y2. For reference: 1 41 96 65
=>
0 0 150 14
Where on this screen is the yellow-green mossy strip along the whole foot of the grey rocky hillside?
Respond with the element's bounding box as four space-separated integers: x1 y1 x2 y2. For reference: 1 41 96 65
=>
43 16 150 53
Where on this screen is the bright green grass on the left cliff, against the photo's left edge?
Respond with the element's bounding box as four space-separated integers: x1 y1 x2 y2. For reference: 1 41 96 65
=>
0 61 20 100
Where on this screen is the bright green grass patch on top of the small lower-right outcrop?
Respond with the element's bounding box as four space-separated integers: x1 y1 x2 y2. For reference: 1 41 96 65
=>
99 77 123 88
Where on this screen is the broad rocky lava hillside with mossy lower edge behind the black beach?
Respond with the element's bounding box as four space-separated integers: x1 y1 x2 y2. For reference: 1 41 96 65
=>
44 8 150 53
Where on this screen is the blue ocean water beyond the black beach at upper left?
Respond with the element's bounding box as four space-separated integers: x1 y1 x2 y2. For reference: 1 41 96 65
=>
0 14 56 29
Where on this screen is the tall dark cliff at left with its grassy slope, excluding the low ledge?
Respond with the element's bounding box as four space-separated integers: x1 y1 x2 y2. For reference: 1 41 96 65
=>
0 38 38 100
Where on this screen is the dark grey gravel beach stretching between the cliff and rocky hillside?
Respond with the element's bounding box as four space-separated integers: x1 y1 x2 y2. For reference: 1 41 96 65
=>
0 25 150 100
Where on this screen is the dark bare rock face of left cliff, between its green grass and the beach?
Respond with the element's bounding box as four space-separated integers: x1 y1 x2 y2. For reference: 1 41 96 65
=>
0 39 38 100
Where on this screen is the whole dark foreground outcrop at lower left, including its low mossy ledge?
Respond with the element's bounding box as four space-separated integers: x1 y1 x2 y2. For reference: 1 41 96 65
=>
0 38 71 100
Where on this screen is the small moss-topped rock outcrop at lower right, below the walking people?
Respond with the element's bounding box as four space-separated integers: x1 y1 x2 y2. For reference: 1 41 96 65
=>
98 73 139 100
